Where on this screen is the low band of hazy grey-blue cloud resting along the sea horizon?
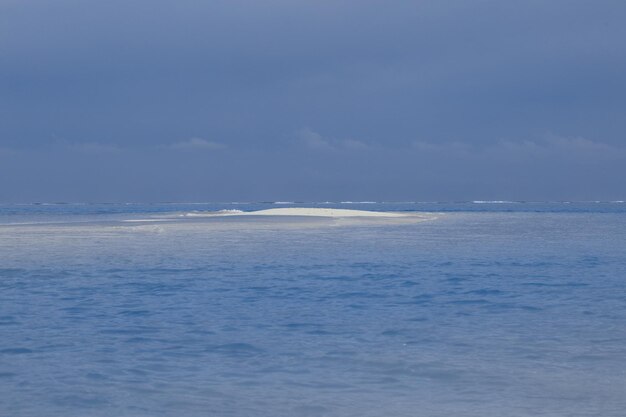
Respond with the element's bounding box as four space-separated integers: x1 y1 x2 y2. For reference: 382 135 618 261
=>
0 134 626 201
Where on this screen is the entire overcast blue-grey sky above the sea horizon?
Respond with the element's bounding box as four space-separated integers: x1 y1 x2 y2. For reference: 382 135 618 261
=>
0 0 626 203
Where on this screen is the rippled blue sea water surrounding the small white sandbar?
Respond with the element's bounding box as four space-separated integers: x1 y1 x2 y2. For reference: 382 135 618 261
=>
0 202 626 417
